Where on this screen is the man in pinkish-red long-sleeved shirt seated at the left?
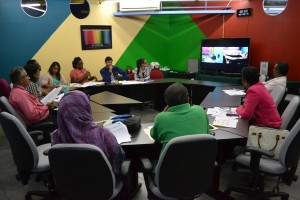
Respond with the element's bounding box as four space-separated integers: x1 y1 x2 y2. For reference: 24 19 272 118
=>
9 67 57 126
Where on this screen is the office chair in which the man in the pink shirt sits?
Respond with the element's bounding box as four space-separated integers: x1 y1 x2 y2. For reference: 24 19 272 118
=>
0 96 57 144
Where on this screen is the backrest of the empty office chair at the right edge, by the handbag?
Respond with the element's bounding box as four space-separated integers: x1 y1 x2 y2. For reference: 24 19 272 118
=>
278 119 300 168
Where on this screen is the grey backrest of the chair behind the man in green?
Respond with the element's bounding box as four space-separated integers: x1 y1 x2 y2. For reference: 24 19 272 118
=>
155 134 217 198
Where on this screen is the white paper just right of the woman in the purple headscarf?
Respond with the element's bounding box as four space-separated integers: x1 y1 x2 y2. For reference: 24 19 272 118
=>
104 122 131 144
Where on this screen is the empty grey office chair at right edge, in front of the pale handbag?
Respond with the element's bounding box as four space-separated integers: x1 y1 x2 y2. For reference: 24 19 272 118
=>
225 119 300 200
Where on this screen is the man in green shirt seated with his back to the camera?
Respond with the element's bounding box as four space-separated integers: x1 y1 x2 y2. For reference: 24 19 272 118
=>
150 83 209 152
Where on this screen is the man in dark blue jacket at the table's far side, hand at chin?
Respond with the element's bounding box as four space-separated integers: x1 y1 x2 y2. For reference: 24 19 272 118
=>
100 56 128 82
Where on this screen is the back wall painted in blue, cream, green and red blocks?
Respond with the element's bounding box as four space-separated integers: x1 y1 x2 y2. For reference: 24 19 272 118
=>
0 0 300 81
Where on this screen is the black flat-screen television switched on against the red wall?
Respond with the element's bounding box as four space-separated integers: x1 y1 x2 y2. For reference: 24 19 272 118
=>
200 38 250 73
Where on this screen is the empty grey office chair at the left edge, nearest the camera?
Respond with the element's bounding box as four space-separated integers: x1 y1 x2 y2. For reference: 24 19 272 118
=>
0 112 53 200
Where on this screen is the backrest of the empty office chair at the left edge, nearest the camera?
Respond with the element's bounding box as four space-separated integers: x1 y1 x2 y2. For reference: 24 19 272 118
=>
0 112 39 171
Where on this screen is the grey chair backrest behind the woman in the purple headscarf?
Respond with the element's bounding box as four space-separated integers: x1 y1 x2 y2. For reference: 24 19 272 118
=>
48 144 116 200
